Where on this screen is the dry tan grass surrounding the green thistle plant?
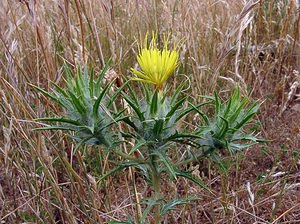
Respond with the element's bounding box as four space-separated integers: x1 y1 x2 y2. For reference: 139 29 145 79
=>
0 0 300 224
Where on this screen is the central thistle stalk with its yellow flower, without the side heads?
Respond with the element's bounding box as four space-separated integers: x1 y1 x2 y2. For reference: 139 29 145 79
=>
114 35 208 223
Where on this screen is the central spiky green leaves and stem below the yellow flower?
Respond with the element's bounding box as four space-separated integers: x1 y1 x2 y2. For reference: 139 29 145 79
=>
118 83 208 223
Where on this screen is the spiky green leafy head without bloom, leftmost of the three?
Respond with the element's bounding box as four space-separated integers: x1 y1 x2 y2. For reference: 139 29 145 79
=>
34 65 119 147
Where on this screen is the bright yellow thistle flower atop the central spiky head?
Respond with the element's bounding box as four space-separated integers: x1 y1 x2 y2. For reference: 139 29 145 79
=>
131 34 178 90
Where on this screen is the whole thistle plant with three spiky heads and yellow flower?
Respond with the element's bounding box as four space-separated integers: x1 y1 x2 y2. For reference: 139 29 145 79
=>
35 34 261 224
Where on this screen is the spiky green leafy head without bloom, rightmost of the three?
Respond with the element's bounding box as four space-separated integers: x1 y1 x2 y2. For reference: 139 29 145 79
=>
196 88 264 156
